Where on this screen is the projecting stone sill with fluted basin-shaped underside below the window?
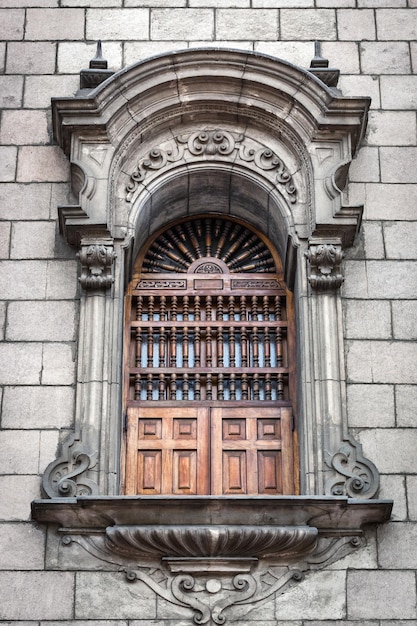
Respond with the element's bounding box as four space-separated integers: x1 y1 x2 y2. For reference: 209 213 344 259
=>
32 496 392 571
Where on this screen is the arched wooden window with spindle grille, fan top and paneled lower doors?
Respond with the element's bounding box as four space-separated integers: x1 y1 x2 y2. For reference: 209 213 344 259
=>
125 215 297 495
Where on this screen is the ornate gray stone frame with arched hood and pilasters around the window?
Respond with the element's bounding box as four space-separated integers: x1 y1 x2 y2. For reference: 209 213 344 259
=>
33 49 390 623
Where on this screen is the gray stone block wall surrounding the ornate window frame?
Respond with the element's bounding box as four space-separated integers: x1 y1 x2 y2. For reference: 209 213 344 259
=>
0 0 417 626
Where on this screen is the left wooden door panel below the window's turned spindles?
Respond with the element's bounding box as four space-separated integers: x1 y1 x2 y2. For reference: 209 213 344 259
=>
126 407 210 495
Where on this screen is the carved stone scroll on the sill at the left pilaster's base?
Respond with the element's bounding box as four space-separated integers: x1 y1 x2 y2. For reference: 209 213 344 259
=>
42 433 98 498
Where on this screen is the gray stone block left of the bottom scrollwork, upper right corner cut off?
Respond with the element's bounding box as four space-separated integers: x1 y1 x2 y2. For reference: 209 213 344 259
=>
75 572 156 620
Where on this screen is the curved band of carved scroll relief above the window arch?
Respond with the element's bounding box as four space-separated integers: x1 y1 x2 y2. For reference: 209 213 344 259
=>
126 129 297 204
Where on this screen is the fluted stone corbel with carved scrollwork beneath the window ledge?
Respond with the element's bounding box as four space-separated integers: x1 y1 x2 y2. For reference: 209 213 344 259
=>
62 526 365 625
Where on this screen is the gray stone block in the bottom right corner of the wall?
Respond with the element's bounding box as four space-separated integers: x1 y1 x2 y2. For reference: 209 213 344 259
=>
347 570 416 620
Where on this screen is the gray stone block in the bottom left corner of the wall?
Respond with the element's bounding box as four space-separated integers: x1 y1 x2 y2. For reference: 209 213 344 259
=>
0 572 74 620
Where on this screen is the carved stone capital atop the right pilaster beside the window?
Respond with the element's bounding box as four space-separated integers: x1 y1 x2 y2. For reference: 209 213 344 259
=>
305 243 344 291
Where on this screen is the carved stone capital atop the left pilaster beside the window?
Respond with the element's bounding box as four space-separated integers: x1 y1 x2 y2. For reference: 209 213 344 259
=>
77 241 116 290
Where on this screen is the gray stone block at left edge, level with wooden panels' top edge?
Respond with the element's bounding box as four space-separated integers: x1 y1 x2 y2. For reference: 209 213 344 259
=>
1 386 74 429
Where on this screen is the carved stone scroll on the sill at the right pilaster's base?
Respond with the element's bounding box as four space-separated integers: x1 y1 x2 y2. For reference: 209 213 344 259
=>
325 437 379 499
